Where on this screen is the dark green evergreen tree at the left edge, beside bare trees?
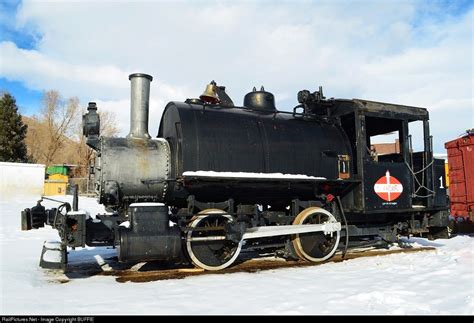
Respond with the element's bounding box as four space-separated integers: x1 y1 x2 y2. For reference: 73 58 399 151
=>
0 93 28 162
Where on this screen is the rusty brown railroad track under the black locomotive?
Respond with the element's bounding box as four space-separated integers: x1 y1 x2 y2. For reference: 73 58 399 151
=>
50 247 436 283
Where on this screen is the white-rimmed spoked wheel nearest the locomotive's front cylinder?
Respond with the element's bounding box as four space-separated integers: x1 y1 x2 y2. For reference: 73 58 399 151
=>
186 209 242 270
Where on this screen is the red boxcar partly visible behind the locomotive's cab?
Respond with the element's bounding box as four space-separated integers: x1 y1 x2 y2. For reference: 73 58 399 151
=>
444 129 474 222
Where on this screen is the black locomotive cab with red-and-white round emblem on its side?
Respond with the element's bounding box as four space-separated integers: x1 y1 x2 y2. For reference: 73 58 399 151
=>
334 99 447 237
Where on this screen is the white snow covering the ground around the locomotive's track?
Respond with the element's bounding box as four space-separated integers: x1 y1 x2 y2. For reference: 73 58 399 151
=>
0 197 474 315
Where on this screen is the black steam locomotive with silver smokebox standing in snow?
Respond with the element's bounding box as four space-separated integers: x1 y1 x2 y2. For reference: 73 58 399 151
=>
21 73 448 270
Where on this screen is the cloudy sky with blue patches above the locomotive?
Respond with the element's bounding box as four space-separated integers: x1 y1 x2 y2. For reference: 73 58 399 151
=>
0 0 474 151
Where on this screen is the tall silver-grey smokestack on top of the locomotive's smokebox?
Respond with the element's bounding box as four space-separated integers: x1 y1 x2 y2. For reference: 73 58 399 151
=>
127 73 153 139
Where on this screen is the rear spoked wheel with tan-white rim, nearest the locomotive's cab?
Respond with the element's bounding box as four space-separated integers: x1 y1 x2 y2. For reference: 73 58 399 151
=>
292 207 341 262
